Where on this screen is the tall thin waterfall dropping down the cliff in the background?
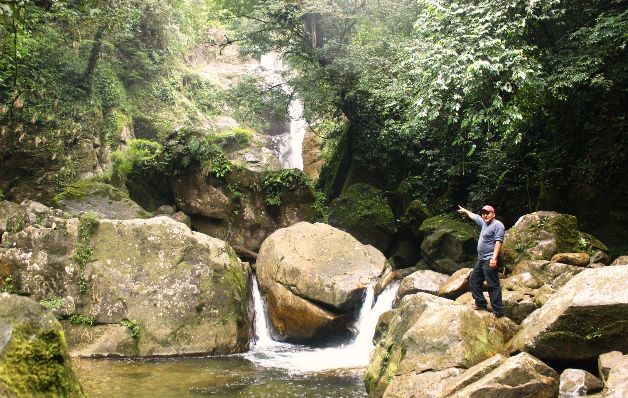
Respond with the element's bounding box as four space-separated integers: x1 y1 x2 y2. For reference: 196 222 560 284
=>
259 52 307 170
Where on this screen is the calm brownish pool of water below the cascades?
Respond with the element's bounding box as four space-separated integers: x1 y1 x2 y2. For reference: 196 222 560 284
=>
73 356 367 398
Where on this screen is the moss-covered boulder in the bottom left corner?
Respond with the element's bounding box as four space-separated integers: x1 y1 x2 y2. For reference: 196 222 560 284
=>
0 293 85 397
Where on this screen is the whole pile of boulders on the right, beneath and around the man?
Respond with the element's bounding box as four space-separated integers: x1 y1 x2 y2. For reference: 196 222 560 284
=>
365 212 628 398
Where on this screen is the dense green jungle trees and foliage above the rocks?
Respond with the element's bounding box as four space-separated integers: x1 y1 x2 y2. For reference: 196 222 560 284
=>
0 0 628 252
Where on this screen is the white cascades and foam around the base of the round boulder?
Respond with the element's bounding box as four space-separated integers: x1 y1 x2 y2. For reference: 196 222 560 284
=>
244 280 399 373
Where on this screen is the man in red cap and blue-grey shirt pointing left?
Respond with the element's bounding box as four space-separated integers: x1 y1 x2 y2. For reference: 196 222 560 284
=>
458 205 505 318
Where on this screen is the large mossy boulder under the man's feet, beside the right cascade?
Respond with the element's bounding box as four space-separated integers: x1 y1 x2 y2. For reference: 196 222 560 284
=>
365 293 508 397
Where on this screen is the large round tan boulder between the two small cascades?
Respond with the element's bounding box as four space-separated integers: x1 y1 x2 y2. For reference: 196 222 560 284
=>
256 222 386 342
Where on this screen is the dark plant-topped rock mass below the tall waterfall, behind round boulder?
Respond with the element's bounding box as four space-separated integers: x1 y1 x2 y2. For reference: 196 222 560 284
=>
170 168 315 253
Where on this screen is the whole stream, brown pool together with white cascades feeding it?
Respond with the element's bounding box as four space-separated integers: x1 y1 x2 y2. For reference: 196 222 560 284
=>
73 281 398 398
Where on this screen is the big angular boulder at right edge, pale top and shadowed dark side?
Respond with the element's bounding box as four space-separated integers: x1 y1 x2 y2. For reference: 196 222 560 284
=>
509 266 628 362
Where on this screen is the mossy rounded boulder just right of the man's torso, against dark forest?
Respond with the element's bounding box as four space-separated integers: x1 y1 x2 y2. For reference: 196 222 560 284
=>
502 211 608 269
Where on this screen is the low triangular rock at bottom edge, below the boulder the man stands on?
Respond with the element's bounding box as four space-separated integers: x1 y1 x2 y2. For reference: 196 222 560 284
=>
448 352 558 398
